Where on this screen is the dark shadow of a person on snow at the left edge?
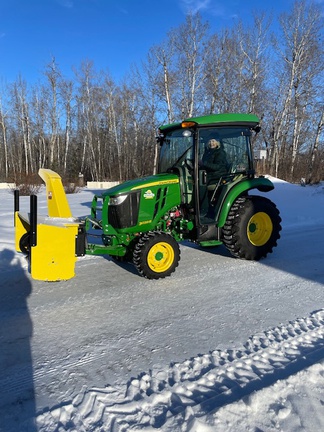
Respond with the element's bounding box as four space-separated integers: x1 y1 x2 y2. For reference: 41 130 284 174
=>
0 249 36 432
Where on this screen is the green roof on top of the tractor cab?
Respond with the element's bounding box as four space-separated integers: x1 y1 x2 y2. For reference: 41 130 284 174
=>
159 113 260 132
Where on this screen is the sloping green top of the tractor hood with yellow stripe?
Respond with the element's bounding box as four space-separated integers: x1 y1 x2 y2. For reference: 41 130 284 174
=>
102 173 179 197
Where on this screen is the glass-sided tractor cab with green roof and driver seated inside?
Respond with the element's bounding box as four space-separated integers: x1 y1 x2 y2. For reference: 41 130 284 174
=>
159 114 260 240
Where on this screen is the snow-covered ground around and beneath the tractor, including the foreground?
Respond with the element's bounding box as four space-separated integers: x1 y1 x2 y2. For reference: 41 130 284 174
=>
0 179 324 432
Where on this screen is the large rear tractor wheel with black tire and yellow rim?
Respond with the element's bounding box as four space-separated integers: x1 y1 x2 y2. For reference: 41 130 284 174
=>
223 196 281 261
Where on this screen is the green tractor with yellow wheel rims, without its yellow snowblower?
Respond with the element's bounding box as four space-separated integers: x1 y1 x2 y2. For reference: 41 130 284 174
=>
80 113 281 279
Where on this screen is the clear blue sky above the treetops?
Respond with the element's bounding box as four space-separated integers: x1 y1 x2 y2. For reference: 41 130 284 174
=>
0 0 316 83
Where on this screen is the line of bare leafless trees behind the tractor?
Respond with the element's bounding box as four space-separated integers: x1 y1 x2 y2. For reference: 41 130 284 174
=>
0 0 324 182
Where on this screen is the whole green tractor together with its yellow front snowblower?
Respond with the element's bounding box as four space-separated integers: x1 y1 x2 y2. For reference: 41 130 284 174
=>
15 114 281 281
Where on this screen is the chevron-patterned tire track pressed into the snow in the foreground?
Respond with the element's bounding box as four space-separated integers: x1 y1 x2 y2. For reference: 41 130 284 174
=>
33 310 324 432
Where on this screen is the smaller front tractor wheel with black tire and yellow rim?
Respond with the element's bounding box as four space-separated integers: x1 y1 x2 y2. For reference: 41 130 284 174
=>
133 232 180 279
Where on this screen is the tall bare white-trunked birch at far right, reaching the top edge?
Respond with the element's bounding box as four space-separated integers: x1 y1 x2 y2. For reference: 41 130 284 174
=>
272 0 323 180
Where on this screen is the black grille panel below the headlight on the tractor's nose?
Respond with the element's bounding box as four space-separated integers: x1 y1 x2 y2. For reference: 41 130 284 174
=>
108 191 141 229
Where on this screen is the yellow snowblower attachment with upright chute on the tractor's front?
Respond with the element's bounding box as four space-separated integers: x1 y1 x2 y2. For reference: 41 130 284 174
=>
15 169 82 281
